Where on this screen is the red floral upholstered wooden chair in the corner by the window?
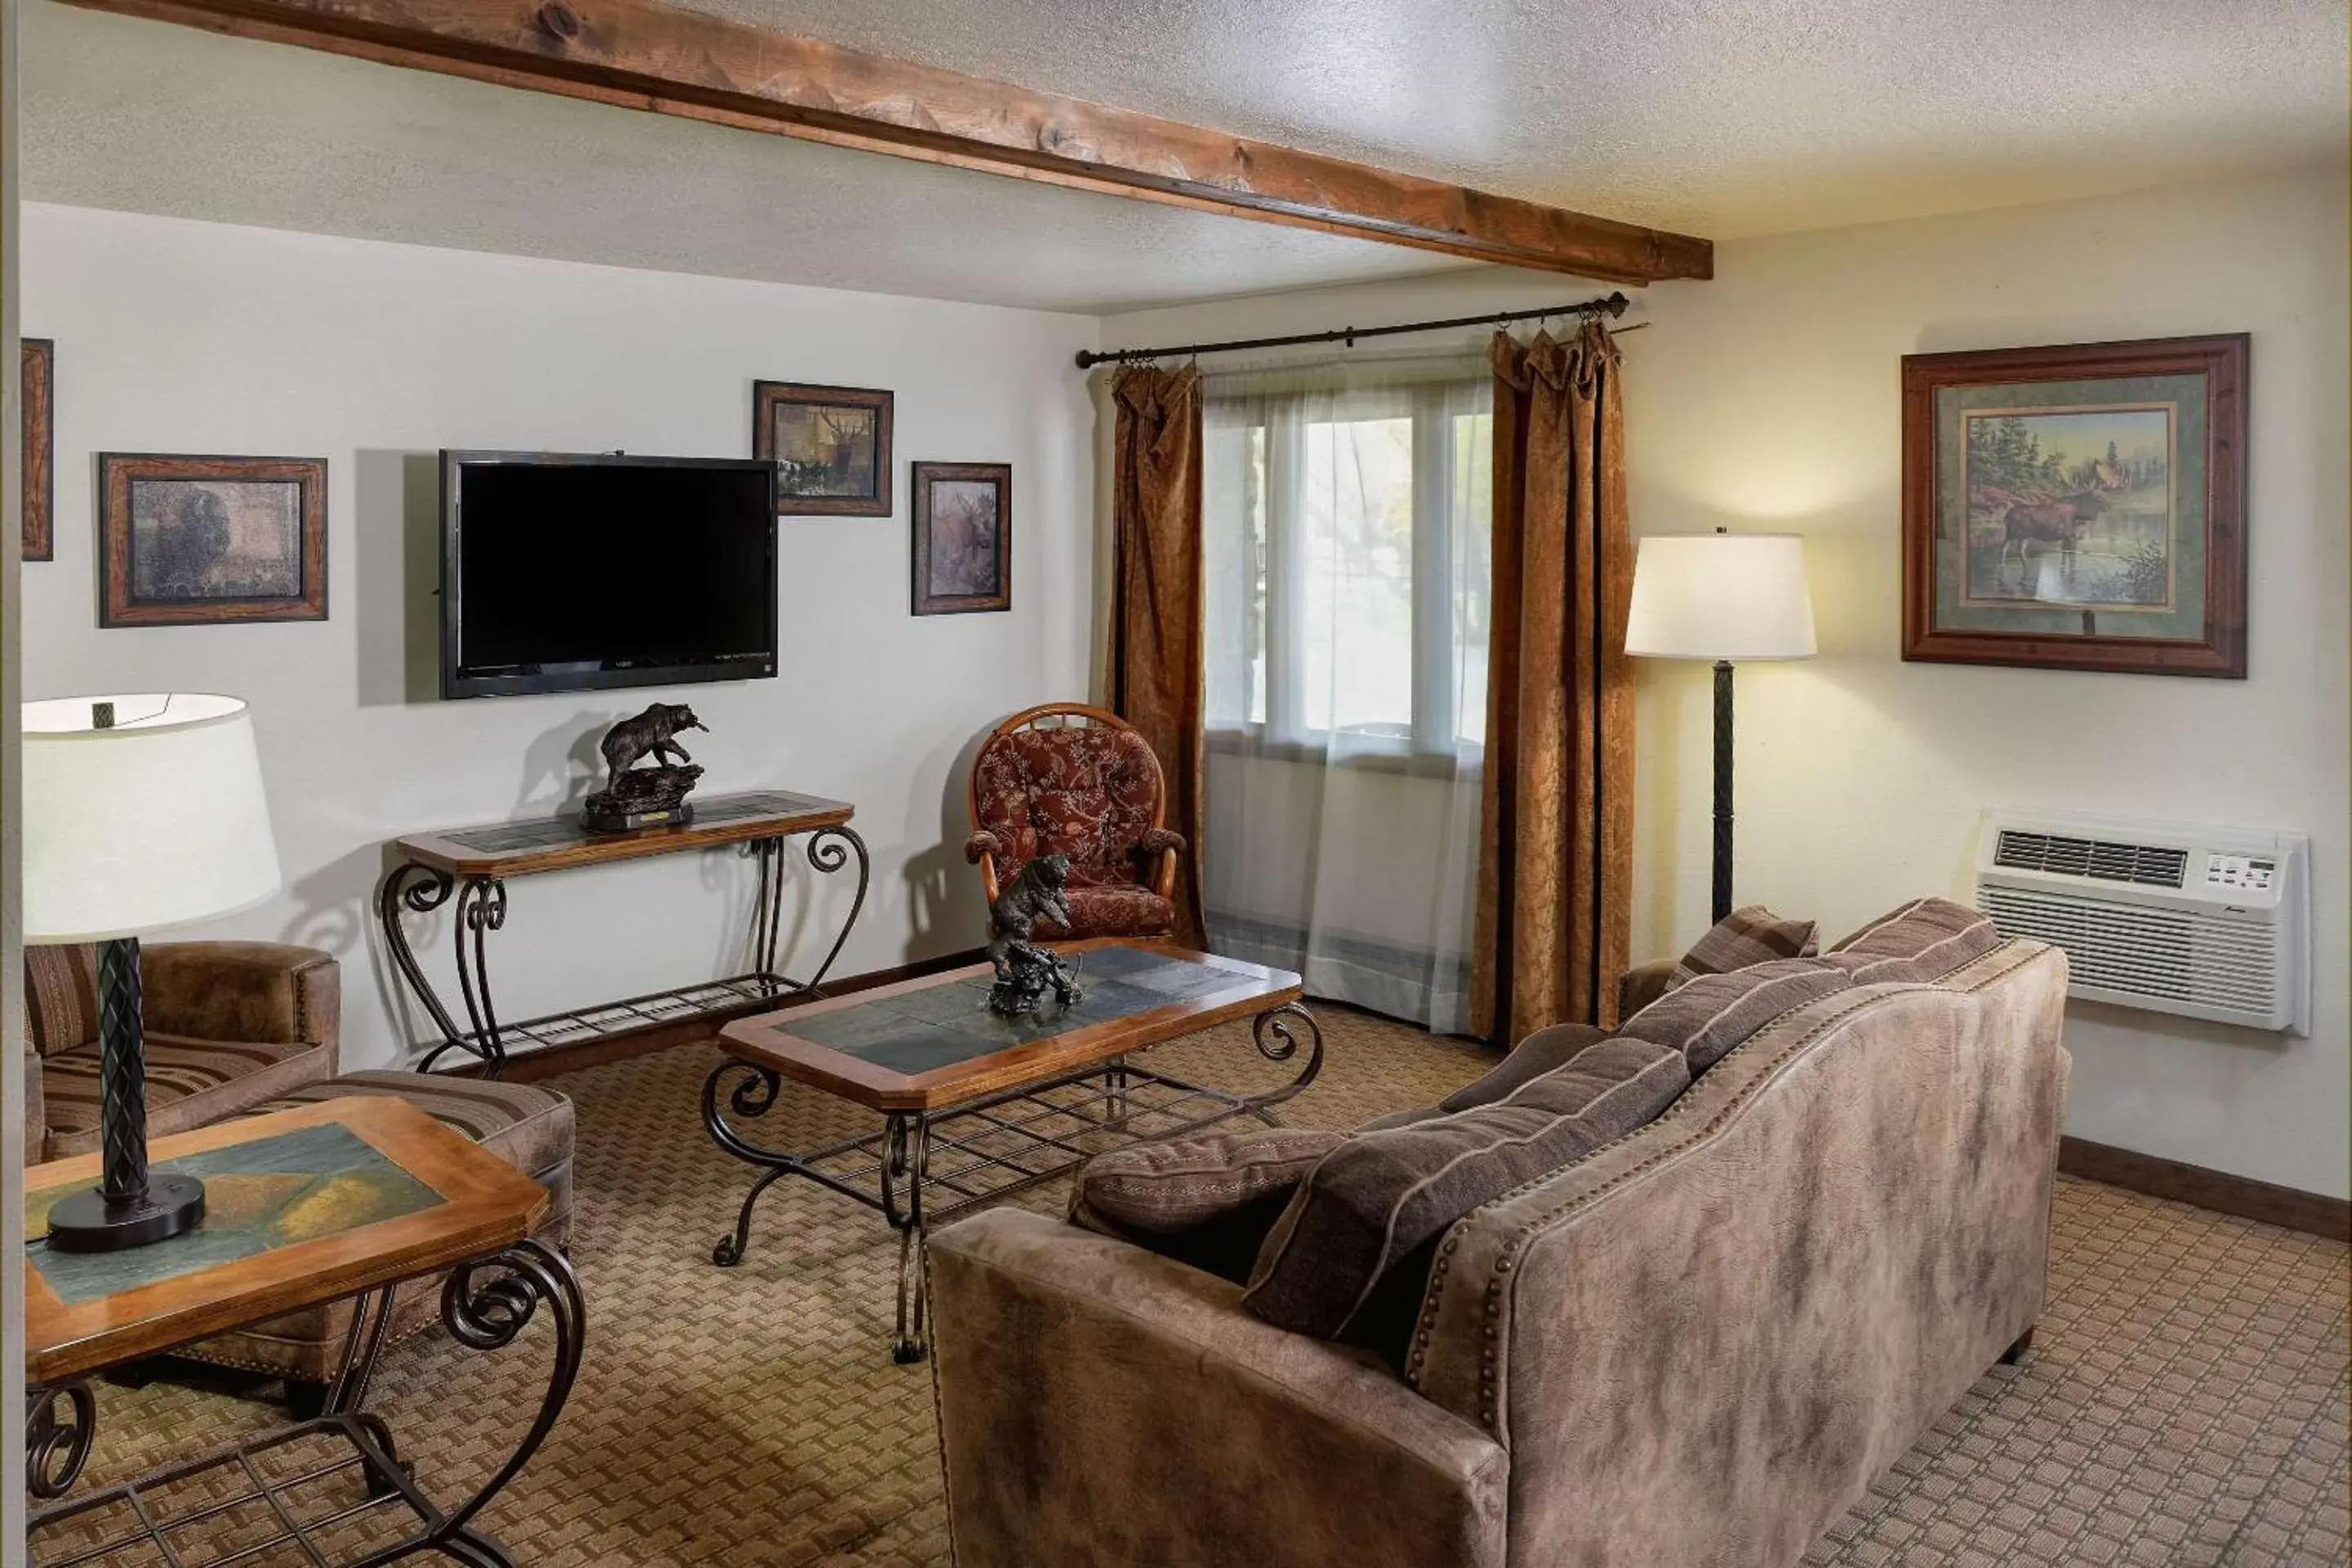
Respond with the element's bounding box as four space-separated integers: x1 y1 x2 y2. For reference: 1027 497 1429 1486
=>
964 703 1186 940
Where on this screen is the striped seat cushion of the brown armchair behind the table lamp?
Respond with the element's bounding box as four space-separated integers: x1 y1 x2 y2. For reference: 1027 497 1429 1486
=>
40 1030 334 1159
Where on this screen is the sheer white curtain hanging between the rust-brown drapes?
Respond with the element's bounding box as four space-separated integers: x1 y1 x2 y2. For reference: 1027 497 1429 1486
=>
1202 355 1494 1032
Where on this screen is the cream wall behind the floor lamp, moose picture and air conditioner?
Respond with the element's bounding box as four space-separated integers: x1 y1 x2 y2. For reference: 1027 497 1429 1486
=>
1103 167 2352 1196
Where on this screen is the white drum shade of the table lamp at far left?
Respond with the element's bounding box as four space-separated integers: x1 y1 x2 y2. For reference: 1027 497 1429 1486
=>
24 693 278 942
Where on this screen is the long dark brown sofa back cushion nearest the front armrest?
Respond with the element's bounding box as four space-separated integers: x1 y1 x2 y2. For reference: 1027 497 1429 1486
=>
1242 1039 1691 1361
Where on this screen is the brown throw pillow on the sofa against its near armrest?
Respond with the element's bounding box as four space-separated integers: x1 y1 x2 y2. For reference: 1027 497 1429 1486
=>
1070 1126 1345 1284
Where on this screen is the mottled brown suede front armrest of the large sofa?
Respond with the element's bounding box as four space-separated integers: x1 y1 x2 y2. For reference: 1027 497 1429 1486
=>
929 1210 1510 1568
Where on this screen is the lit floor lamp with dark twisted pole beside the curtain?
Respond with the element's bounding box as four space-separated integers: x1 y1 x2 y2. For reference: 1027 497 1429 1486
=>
1625 529 1813 920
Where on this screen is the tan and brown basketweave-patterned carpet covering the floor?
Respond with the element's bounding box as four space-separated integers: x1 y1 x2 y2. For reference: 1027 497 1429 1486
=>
45 1009 2352 1568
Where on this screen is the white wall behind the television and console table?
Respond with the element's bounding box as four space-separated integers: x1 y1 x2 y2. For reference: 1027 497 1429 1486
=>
24 204 1094 1065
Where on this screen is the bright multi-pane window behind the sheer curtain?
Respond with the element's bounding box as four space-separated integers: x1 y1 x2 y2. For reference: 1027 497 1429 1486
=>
1202 367 1494 760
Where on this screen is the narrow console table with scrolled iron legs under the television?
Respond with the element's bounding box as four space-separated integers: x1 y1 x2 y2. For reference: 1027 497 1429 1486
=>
376 790 872 1076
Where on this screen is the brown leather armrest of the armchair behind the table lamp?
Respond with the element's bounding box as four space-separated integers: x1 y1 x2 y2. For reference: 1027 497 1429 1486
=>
139 942 343 1076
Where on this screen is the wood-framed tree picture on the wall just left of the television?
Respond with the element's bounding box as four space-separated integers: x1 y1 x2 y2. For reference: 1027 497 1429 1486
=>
99 452 327 628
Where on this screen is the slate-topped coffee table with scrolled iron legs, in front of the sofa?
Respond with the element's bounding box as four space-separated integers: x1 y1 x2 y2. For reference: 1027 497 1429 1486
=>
703 938 1322 1364
